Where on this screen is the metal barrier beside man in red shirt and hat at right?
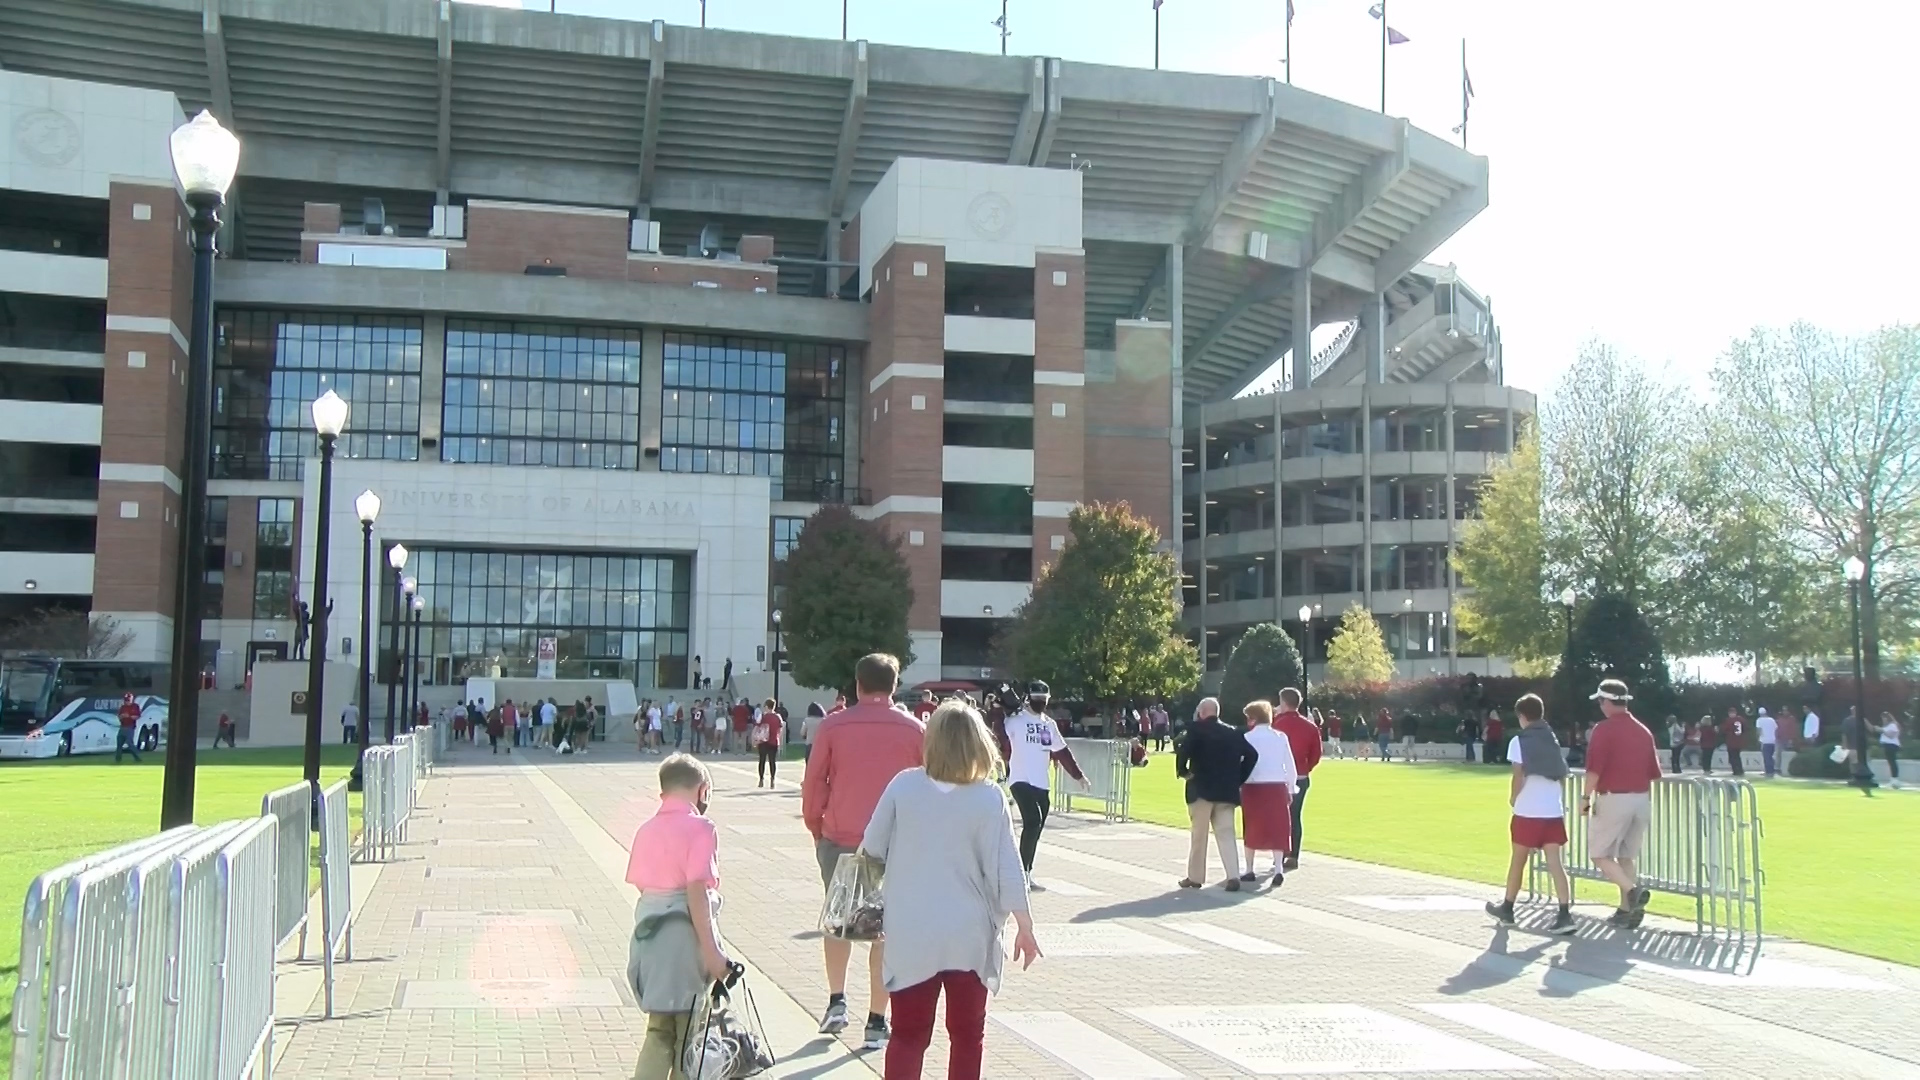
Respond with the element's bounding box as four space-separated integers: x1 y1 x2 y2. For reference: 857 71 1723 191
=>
1528 773 1766 957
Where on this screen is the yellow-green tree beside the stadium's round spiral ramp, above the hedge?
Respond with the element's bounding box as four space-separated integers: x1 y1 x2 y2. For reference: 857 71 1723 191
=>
1453 432 1561 663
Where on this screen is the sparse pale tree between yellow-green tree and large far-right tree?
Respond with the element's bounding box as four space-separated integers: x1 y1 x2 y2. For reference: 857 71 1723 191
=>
1542 342 1695 626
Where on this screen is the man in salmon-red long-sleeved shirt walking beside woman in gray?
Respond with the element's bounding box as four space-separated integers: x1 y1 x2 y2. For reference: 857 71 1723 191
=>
801 653 927 1049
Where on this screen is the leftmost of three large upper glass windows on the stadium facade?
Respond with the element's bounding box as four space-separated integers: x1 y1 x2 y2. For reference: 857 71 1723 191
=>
213 309 420 480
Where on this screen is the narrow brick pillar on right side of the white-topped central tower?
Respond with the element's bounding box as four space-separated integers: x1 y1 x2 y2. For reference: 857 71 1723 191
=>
1033 252 1087 577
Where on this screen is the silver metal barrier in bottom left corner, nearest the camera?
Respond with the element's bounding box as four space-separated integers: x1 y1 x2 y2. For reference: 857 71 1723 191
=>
12 817 278 1080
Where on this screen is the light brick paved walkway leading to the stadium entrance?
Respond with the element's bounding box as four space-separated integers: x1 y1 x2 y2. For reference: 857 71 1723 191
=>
276 748 1920 1080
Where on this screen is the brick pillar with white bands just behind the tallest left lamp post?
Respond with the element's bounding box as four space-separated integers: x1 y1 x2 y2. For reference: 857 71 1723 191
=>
92 183 194 659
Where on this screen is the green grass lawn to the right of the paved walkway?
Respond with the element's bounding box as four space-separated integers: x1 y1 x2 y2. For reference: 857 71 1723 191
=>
1133 753 1920 965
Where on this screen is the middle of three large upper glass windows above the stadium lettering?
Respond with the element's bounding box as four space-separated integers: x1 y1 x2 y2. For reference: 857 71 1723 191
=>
440 319 639 469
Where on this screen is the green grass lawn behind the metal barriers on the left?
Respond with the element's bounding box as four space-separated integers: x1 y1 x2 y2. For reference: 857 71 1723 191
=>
0 746 359 1076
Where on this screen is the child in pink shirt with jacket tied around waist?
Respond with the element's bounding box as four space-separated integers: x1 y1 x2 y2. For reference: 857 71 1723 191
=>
626 753 730 1080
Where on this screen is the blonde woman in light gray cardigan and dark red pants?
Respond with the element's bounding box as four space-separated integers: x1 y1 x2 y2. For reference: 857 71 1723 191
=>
860 701 1041 1080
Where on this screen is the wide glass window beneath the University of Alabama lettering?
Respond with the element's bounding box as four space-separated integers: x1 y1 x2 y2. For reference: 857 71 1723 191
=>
380 548 693 688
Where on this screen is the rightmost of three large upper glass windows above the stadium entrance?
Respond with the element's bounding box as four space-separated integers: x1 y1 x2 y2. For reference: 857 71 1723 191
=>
660 334 847 502
